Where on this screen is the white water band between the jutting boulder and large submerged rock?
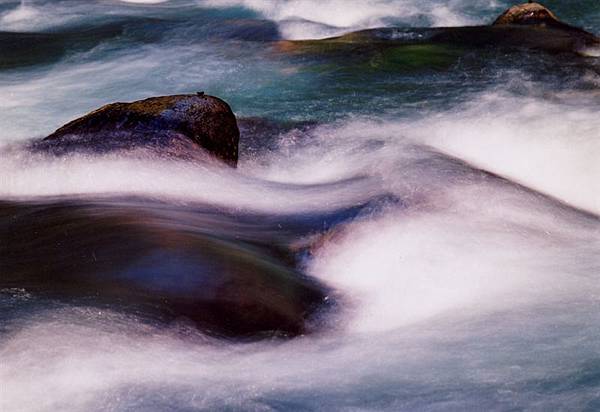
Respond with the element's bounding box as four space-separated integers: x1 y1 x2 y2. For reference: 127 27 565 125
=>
0 151 378 213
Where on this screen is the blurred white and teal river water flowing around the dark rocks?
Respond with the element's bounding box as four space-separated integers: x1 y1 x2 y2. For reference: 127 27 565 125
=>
0 0 600 412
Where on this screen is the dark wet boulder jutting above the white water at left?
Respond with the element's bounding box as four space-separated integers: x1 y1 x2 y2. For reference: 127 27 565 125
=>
39 93 239 166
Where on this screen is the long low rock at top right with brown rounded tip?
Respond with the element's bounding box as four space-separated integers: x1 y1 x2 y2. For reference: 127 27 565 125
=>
276 3 600 57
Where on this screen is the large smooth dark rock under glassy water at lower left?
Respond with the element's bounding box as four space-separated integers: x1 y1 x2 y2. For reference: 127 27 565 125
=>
0 199 328 339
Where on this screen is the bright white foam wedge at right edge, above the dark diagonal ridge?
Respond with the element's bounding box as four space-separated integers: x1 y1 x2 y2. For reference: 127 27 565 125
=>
420 94 600 214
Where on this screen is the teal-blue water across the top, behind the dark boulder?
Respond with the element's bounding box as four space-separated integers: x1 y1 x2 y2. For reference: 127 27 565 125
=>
0 1 600 140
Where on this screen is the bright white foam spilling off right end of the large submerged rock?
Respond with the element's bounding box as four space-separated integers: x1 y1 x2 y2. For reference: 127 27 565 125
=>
311 184 600 333
